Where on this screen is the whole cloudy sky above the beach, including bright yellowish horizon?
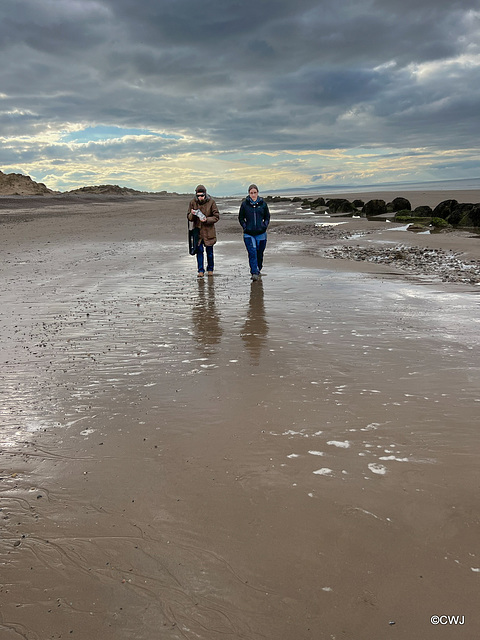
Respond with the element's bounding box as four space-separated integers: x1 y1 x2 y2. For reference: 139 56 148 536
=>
0 0 480 196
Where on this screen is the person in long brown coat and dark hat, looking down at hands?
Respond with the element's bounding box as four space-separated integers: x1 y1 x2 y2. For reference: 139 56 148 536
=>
187 184 220 278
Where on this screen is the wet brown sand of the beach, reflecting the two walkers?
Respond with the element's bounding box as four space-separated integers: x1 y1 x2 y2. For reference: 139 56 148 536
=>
0 193 480 640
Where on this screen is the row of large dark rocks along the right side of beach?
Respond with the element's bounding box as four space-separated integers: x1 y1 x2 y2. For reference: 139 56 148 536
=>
265 196 480 227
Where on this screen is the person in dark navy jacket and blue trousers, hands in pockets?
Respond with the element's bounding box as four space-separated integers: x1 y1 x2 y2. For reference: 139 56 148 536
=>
238 184 270 280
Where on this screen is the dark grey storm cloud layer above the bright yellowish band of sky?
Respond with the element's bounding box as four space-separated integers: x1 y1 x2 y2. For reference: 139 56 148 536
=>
0 0 480 164
